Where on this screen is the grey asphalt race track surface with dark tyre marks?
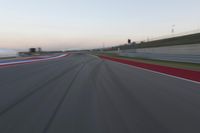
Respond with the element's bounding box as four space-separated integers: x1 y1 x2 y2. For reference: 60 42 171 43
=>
0 54 200 133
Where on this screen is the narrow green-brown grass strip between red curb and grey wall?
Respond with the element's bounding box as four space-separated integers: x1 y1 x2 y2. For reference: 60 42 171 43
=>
98 53 200 71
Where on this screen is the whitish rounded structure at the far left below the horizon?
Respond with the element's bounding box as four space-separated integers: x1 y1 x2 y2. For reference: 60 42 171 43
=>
0 48 18 58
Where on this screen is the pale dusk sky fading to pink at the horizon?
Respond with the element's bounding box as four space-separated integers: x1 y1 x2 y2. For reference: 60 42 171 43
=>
0 0 200 50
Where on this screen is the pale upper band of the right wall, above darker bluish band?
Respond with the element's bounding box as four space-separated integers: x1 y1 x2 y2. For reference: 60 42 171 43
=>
121 44 200 55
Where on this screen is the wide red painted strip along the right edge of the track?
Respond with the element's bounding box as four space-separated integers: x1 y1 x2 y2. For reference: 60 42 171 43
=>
100 55 200 82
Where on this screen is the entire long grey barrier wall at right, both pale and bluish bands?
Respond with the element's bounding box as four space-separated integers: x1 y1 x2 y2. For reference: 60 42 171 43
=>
106 44 200 64
